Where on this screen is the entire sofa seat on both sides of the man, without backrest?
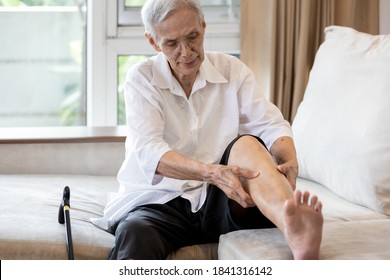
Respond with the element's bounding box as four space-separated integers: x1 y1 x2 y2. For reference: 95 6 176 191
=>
0 174 390 260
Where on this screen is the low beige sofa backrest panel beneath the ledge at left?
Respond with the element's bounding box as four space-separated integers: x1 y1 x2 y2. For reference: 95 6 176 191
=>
0 142 125 176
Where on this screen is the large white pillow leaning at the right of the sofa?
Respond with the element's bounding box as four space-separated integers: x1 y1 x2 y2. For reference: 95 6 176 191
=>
293 26 390 215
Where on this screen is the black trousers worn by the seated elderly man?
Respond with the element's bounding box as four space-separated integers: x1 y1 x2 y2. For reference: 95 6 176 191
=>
108 136 275 260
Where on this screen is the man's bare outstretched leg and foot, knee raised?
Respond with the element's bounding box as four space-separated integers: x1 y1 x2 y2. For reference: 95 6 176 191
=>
229 136 323 259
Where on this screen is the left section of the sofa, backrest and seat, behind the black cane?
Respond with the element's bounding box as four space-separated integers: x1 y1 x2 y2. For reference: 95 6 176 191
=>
0 127 217 260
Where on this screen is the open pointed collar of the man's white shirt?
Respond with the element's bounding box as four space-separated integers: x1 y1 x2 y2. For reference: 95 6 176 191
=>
151 52 228 93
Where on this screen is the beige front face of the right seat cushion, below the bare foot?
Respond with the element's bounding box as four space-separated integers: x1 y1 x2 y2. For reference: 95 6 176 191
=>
218 220 390 260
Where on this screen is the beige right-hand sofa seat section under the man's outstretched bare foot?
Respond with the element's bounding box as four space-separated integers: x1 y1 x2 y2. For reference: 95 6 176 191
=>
218 178 390 260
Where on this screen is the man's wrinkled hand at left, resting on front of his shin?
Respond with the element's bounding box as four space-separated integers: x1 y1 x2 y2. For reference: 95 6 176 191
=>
207 164 260 208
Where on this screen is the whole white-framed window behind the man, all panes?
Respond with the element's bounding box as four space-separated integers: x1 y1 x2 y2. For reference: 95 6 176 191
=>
0 0 240 127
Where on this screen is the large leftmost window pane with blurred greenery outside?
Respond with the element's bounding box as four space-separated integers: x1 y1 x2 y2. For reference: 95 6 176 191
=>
0 0 86 127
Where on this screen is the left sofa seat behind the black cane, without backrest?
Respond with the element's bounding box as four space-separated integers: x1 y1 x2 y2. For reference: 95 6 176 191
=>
0 174 217 260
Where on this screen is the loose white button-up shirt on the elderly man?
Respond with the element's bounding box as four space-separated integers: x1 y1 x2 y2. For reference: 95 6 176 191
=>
92 53 292 229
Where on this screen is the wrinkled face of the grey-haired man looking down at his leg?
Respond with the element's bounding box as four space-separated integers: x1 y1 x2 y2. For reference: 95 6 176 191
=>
146 9 206 82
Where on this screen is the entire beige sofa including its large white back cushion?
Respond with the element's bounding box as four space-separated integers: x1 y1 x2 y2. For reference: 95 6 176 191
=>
0 26 390 260
